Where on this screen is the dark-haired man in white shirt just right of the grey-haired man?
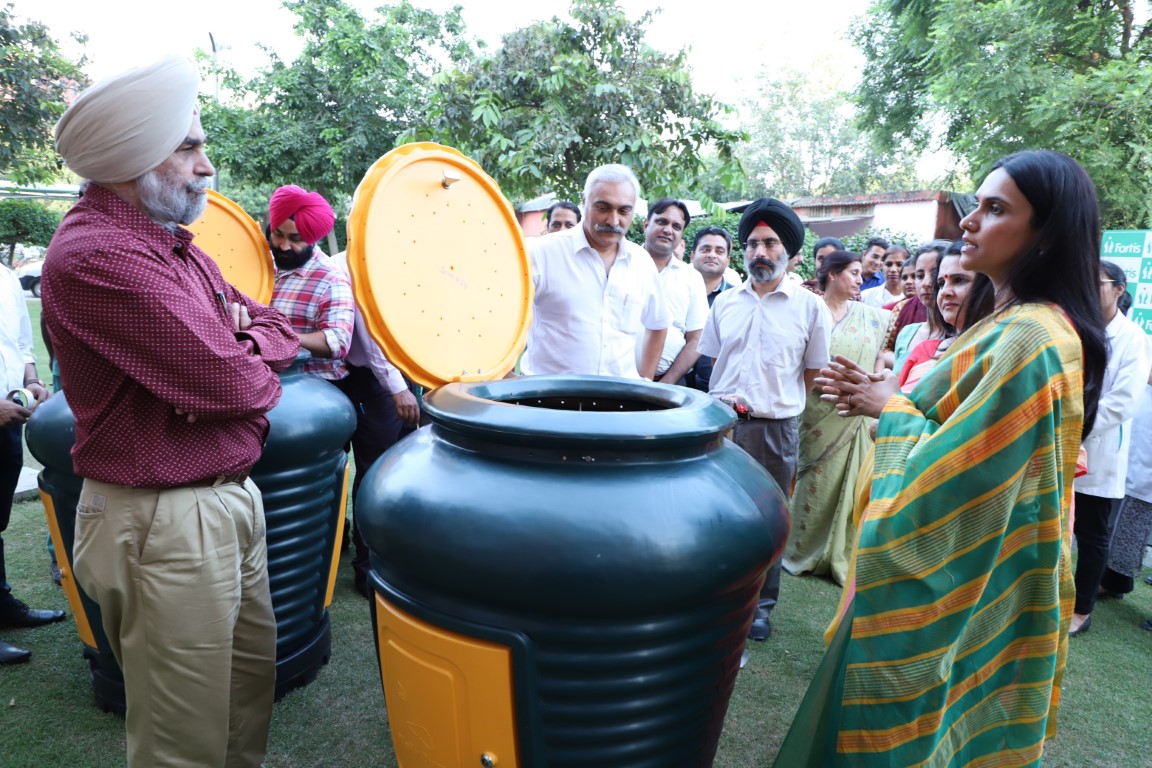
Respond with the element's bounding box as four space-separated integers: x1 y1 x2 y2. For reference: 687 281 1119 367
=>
636 197 708 386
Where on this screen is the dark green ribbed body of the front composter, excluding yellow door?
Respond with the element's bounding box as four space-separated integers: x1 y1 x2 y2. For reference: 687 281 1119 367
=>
357 377 788 768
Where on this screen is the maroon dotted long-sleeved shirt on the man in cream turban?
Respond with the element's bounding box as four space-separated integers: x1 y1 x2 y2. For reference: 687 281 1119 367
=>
41 184 300 488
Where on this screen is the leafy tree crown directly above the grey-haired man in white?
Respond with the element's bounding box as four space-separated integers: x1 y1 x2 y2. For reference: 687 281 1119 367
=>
404 0 740 200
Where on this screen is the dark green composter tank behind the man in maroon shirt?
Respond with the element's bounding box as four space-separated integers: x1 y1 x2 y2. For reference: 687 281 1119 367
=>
26 358 356 713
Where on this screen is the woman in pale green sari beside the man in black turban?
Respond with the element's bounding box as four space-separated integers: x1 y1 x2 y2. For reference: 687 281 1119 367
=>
783 251 892 584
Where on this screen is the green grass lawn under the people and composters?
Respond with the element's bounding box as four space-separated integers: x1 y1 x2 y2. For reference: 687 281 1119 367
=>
9 302 1152 768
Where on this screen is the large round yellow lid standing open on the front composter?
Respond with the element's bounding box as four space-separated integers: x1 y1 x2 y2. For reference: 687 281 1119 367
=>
348 143 532 387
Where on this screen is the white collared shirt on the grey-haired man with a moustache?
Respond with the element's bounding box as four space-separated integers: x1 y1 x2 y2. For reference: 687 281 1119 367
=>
520 226 668 379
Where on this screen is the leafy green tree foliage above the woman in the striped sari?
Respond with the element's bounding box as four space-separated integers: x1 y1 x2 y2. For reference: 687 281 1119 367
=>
854 0 1152 228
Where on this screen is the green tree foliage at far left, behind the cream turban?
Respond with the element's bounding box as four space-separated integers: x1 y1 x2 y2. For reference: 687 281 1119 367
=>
0 3 86 184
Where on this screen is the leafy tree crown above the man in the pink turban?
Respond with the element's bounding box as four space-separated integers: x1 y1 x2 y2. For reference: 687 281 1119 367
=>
204 0 469 205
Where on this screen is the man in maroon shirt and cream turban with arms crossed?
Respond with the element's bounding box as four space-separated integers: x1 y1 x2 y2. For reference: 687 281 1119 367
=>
43 58 300 768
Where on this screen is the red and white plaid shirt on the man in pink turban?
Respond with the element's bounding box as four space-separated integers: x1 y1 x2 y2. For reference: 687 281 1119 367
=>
272 252 356 381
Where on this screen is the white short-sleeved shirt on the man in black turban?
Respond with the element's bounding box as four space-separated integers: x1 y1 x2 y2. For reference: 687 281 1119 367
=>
699 280 832 419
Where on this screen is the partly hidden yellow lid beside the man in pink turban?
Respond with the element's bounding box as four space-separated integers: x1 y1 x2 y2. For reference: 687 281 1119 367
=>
188 189 275 304
